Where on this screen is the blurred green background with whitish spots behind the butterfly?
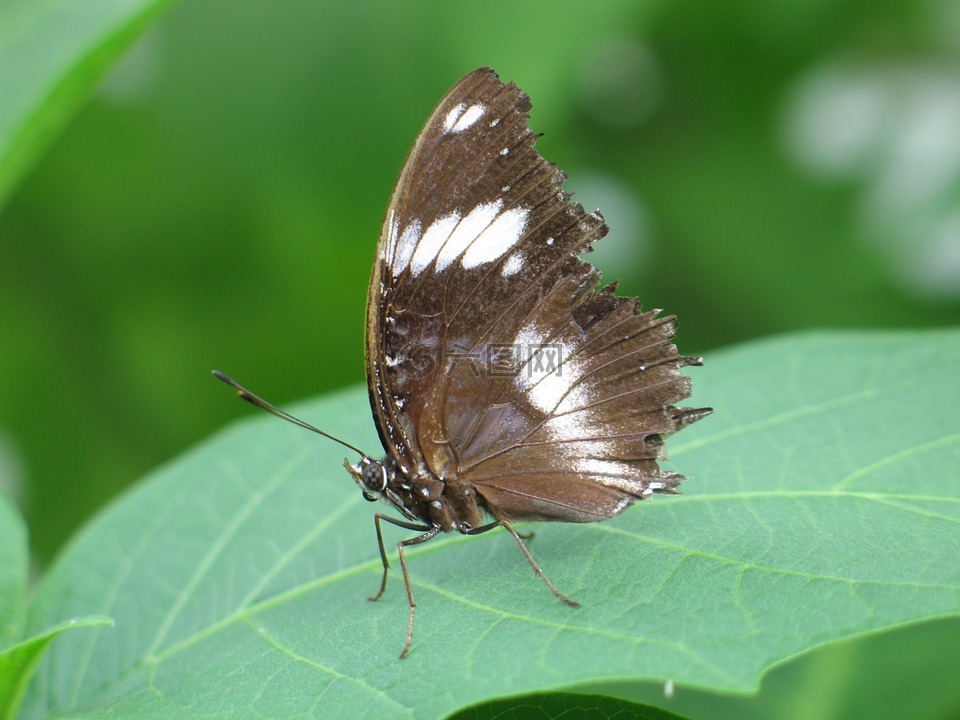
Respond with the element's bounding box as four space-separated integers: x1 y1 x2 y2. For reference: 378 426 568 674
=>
0 0 960 600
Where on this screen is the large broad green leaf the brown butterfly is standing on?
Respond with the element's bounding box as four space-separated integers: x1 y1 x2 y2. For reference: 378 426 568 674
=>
20 331 960 718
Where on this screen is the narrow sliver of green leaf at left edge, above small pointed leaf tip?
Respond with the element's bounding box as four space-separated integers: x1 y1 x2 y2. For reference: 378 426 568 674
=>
0 489 29 650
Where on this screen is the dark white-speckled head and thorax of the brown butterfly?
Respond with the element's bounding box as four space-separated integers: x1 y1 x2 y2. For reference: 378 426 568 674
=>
344 456 483 533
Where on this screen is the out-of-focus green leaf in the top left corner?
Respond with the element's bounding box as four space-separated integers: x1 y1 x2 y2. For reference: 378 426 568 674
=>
0 0 175 206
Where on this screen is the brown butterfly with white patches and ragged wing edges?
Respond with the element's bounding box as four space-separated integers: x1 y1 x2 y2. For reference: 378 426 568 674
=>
215 68 712 658
